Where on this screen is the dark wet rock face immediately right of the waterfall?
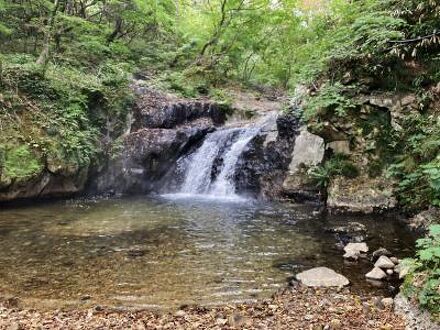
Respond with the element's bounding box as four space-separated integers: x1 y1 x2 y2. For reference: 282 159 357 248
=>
236 115 299 198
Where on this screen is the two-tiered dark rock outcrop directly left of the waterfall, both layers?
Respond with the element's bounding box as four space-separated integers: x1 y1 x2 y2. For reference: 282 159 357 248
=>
89 82 226 194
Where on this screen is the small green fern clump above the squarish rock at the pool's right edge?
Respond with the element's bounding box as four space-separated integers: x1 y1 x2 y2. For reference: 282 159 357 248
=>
308 154 359 188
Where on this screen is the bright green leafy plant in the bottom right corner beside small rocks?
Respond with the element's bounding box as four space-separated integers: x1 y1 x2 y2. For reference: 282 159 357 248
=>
403 224 440 319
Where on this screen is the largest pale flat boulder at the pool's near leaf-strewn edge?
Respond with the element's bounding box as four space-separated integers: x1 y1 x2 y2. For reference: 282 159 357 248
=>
296 267 350 287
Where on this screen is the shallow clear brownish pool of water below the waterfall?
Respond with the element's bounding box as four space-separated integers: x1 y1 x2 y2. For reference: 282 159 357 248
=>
0 195 413 308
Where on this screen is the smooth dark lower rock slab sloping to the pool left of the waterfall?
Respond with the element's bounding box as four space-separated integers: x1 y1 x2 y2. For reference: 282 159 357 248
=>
92 125 213 194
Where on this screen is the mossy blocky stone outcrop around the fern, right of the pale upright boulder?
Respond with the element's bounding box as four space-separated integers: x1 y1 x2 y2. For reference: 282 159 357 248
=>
304 90 420 213
